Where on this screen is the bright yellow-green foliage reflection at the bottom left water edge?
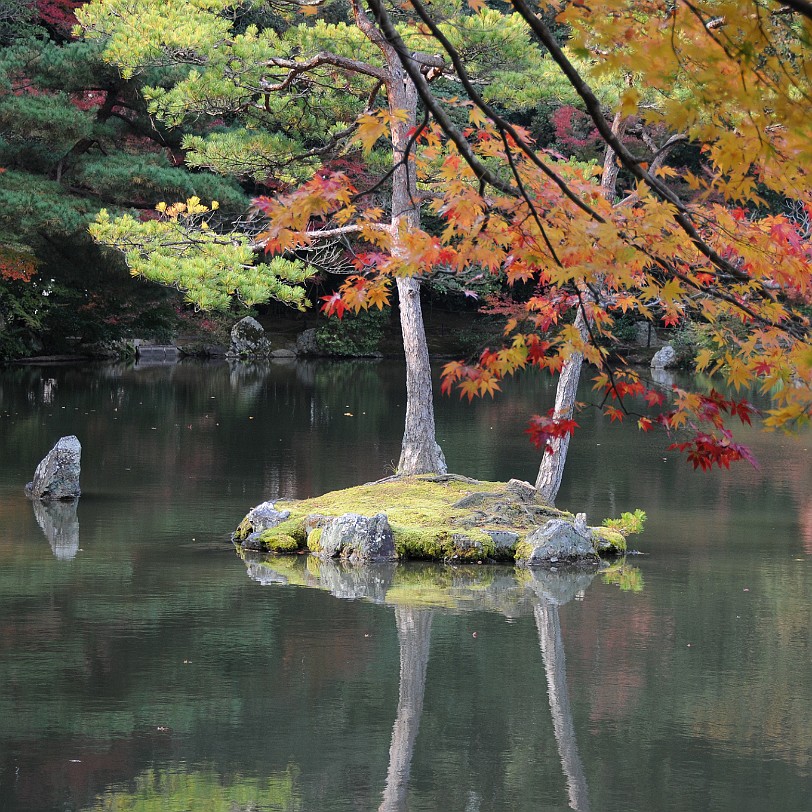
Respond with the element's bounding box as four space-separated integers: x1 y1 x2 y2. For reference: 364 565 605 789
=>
88 766 302 812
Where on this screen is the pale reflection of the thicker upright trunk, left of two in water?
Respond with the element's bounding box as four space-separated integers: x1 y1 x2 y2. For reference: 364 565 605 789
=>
379 607 432 812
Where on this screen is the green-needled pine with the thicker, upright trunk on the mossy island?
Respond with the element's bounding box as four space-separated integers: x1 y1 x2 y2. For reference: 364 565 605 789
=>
79 2 552 474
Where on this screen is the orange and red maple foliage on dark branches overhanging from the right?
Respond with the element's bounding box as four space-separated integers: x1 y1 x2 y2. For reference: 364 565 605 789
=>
350 0 812 500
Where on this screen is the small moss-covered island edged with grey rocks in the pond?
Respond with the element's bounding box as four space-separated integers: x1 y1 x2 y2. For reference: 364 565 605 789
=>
233 474 645 569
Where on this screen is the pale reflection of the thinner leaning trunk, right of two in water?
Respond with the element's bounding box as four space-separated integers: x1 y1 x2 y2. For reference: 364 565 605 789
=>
534 598 589 812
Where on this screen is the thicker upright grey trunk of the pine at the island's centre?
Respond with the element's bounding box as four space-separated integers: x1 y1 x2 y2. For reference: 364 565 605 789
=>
353 0 448 476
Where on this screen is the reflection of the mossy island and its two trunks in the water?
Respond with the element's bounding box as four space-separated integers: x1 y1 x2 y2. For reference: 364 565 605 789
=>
240 551 596 812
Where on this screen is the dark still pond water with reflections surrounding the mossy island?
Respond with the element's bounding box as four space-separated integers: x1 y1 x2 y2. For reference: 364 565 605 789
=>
0 363 812 812
